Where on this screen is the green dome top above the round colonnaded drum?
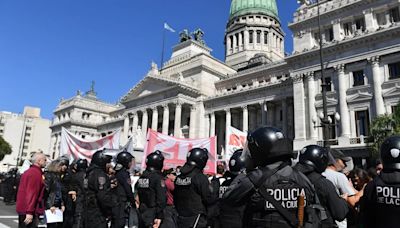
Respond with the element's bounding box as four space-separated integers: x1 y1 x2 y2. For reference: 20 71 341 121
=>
229 0 278 19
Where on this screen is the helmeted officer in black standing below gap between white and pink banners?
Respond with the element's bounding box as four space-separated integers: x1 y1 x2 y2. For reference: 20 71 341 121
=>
112 151 135 228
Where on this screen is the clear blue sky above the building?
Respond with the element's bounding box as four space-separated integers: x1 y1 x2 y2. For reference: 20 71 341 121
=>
0 0 297 119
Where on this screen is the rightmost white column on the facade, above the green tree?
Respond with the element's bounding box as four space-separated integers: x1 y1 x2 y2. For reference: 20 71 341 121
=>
370 56 385 116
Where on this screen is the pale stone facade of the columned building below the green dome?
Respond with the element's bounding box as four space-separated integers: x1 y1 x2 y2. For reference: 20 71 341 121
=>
52 0 400 164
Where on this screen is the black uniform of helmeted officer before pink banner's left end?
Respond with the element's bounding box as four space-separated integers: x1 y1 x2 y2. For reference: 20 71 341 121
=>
136 170 167 227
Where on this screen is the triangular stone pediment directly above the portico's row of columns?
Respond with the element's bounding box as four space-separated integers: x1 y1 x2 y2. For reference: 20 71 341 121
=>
121 76 200 102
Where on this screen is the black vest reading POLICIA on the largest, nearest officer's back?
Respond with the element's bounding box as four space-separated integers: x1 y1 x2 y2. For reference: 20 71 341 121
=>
250 166 328 228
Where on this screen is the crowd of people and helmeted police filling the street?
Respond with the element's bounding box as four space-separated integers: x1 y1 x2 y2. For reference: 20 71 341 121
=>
7 127 400 228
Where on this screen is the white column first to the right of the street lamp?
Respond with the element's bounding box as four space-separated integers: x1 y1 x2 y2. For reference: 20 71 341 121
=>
335 64 350 137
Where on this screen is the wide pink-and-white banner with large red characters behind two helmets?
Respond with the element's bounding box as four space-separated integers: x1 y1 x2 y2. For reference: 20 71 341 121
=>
142 129 217 174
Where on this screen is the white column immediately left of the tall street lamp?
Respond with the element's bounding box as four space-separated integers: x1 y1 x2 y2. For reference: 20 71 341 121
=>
306 72 318 139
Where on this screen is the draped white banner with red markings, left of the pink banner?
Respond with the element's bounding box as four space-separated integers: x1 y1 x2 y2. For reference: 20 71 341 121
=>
60 128 121 162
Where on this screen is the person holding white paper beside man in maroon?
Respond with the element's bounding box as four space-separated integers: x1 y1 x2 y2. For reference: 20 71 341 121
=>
44 160 65 228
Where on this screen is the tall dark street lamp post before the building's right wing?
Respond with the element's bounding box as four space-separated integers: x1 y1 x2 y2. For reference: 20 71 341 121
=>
297 0 332 148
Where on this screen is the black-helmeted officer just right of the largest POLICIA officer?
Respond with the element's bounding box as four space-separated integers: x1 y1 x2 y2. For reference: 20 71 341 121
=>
294 145 349 227
